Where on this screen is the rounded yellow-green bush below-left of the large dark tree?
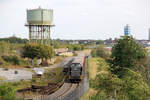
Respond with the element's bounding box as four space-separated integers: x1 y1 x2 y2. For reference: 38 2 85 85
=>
93 72 123 98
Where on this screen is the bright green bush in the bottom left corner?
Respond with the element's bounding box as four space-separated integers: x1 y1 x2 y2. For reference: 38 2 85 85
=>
0 84 16 100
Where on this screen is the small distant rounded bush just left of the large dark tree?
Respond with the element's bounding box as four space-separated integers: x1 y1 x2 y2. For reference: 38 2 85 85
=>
91 45 109 58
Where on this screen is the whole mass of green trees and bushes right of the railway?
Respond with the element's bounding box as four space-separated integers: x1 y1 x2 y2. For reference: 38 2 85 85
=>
90 36 150 100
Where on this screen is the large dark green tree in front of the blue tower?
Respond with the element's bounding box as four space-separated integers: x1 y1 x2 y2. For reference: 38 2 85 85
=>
109 36 146 74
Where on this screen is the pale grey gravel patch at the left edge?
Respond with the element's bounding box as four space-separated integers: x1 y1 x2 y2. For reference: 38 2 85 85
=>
0 68 33 82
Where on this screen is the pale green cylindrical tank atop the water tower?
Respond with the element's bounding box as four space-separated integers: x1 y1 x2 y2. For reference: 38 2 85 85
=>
27 8 53 25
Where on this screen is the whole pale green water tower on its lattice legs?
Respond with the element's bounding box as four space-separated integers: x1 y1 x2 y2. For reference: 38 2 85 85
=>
25 7 54 44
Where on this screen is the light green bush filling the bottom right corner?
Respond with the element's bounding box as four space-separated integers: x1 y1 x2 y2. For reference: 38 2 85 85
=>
122 69 150 100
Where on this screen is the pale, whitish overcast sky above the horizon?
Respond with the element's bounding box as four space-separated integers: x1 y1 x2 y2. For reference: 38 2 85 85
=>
0 0 150 39
